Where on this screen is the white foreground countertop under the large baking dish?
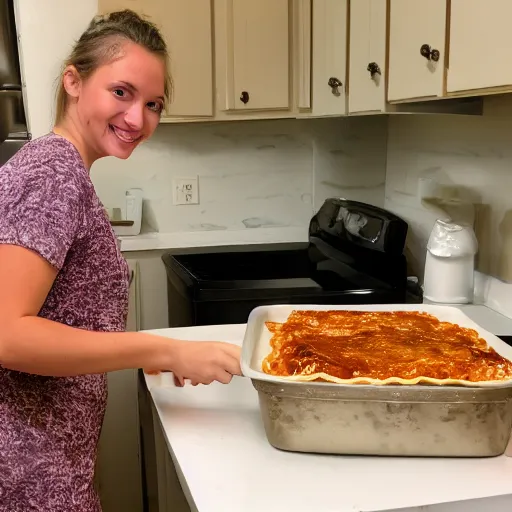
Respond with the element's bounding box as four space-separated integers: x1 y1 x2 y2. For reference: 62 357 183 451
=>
146 306 512 512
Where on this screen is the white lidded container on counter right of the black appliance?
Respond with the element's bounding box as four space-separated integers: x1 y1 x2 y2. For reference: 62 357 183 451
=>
423 219 478 304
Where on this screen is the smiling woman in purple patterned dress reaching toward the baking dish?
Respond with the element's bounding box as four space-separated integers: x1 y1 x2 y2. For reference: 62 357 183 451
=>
0 11 240 512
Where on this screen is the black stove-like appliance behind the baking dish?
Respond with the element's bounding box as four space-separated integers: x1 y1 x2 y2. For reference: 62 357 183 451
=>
162 198 408 327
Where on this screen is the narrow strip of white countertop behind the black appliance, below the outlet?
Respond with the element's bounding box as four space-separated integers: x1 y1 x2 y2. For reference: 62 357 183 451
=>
118 227 308 252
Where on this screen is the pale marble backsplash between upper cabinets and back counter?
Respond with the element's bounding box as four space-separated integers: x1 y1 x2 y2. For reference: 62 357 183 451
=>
92 105 512 288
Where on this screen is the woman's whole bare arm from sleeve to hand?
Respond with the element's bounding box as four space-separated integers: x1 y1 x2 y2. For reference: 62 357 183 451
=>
0 244 240 384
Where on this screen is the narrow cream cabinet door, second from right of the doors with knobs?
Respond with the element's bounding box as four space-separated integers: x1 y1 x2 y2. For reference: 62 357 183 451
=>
348 0 387 113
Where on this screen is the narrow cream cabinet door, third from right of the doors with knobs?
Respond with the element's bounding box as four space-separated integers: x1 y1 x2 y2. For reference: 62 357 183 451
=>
311 0 348 116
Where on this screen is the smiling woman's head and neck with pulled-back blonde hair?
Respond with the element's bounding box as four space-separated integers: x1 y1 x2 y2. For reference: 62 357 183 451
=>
54 11 171 163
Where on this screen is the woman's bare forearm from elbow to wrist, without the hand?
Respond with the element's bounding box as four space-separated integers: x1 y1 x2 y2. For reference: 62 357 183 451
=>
0 316 174 377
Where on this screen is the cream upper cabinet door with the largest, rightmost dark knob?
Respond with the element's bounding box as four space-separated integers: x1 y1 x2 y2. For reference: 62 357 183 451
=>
388 0 447 102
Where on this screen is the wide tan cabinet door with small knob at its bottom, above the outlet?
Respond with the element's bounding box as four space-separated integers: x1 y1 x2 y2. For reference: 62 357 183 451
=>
214 0 293 113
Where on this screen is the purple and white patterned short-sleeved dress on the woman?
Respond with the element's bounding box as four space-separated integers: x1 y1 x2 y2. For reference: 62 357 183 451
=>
0 133 129 512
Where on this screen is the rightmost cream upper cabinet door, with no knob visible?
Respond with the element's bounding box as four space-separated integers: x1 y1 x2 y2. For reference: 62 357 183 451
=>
446 0 512 93
